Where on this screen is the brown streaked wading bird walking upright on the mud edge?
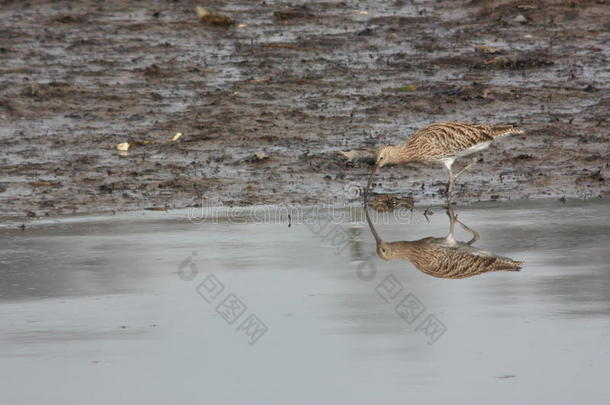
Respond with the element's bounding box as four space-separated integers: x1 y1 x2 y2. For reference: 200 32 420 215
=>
373 121 523 199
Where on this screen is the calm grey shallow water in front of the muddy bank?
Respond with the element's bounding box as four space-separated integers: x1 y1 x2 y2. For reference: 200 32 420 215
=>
0 201 610 405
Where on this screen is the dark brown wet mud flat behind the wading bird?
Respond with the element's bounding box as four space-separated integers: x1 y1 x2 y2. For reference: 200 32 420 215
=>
0 0 610 217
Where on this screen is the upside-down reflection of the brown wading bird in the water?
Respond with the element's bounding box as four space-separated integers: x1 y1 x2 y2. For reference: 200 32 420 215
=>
365 202 524 278
